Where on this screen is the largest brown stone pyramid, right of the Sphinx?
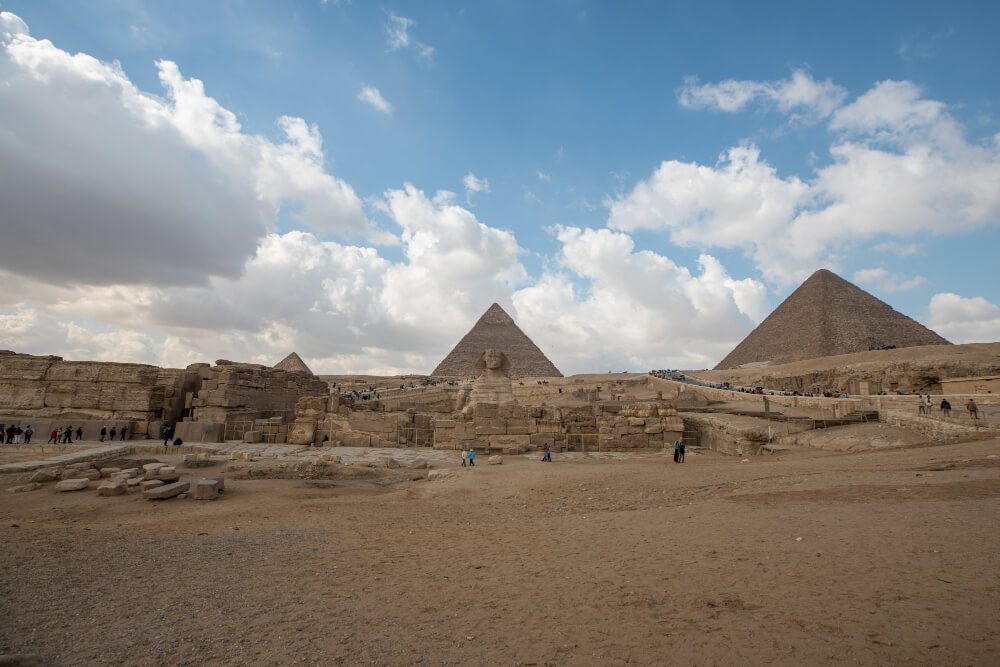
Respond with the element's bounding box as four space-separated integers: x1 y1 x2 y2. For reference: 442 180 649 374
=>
715 269 949 370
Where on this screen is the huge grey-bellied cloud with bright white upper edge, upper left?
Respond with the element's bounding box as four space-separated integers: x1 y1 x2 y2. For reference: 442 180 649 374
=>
0 13 382 284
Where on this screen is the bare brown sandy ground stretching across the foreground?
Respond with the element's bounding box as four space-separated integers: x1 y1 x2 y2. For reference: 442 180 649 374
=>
0 440 1000 665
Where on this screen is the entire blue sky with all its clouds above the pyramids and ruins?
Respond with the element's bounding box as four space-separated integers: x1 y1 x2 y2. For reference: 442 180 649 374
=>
0 0 1000 374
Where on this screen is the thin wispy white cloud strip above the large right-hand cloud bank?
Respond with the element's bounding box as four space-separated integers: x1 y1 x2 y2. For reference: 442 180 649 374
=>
677 70 847 120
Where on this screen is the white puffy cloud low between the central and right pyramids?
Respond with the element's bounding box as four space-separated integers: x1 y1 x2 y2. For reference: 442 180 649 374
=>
513 227 767 373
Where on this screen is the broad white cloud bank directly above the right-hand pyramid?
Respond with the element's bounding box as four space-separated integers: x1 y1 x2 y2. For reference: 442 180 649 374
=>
609 82 1000 285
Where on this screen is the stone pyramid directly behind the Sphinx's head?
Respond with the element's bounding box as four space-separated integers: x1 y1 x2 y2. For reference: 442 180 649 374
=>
431 303 562 377
